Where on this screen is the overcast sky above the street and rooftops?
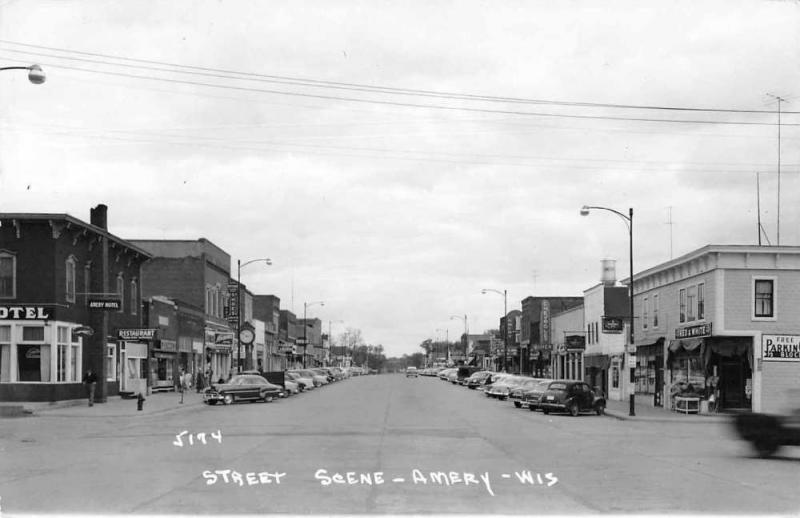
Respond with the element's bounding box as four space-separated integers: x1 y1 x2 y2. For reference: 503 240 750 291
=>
0 0 800 355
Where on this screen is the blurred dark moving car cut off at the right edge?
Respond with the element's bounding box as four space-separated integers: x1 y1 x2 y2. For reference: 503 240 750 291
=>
733 410 800 457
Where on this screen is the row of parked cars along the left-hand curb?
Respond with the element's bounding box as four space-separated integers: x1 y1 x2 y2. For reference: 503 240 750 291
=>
203 367 360 405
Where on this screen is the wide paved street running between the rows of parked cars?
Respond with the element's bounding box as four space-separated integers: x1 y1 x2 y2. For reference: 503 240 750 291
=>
0 375 800 516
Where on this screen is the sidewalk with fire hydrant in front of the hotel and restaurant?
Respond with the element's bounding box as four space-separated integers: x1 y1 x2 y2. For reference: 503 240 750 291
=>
24 390 203 417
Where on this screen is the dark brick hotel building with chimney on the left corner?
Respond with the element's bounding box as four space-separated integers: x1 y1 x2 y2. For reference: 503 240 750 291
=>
0 205 150 402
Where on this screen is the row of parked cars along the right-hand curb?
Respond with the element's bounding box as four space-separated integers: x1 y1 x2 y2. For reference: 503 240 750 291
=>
420 366 606 416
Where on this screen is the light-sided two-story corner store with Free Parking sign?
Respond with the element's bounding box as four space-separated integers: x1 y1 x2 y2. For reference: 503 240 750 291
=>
634 245 800 412
